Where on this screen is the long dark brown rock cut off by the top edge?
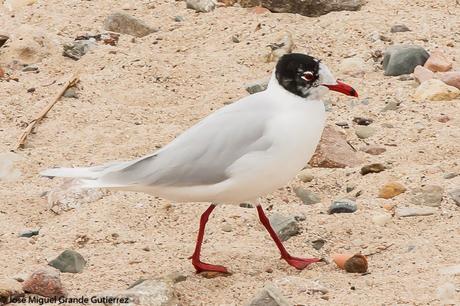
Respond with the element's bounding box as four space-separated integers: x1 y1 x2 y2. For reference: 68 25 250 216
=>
237 0 366 17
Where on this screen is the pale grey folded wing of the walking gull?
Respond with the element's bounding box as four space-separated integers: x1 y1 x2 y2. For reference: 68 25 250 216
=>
101 96 272 187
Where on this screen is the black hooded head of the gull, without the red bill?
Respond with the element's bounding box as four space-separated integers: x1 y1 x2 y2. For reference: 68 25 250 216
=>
275 53 320 98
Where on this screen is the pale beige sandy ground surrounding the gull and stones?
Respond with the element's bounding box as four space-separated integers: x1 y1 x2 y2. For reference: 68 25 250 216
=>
0 0 460 305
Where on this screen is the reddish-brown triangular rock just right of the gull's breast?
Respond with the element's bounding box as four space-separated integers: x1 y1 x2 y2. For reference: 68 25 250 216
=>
309 126 361 168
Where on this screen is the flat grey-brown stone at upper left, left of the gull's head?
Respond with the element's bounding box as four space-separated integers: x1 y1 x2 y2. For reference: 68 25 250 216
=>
104 13 158 37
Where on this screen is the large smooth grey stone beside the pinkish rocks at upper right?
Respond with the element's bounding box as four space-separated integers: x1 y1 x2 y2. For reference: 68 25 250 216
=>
383 45 430 76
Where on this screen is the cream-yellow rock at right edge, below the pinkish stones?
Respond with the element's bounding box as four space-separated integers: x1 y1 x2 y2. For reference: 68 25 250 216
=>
414 79 460 101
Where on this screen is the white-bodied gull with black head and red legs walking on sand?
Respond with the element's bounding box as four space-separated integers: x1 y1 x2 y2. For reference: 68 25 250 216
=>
40 53 358 273
